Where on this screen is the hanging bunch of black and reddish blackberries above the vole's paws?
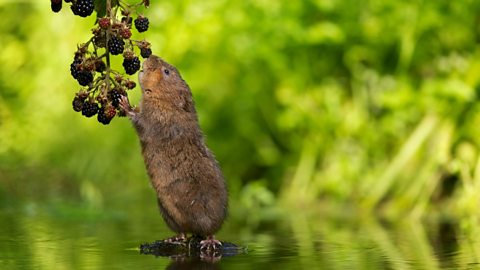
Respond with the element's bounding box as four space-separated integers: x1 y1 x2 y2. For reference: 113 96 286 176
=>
50 0 152 125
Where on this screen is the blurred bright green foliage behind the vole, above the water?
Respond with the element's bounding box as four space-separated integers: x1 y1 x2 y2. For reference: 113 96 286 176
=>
0 0 480 268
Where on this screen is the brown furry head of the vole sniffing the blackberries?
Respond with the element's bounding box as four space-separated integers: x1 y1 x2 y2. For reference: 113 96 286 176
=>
138 55 194 111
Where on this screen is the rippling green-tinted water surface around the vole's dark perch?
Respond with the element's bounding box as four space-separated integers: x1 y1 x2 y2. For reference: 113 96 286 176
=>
0 205 480 269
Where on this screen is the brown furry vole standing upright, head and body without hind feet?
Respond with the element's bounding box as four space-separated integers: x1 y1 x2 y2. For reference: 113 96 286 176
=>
122 55 227 236
